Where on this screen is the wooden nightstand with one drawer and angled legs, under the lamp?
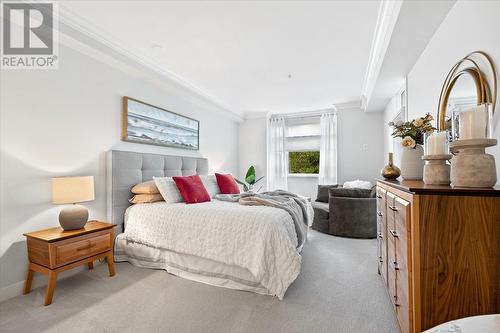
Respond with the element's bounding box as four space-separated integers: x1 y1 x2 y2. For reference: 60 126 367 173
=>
24 221 115 305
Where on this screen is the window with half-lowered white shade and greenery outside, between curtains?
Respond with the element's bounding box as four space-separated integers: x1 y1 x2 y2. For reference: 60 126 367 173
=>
285 117 320 175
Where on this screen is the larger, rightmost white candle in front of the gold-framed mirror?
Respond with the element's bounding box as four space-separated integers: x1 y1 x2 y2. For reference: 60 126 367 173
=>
458 104 487 140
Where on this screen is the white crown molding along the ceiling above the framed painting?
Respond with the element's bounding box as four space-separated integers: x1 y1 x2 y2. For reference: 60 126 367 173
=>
59 3 244 122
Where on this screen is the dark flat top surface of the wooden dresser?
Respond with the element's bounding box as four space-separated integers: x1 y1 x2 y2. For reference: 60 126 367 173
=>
377 179 500 196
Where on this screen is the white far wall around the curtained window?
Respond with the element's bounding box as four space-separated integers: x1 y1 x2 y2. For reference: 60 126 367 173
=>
240 110 385 200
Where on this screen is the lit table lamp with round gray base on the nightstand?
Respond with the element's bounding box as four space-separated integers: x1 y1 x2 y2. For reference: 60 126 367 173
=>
52 176 95 230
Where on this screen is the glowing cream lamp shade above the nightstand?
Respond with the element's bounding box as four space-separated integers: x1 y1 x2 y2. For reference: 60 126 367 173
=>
52 176 95 204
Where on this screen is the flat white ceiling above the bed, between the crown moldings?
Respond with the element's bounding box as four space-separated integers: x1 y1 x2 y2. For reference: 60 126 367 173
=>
60 0 380 115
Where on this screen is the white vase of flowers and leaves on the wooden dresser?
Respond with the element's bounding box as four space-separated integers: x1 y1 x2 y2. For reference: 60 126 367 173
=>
389 114 436 180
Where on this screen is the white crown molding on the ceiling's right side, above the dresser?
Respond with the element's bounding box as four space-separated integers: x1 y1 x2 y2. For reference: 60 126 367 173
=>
361 0 403 110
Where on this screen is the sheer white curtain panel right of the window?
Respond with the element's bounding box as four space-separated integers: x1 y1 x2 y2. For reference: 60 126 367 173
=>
318 113 337 185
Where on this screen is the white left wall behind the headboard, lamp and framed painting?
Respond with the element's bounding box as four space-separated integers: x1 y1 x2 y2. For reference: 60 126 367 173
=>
0 40 239 298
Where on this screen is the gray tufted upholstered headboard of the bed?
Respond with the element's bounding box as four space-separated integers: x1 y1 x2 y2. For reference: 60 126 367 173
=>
107 150 208 232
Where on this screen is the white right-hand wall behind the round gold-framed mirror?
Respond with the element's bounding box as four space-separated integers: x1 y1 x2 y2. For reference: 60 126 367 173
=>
408 1 500 180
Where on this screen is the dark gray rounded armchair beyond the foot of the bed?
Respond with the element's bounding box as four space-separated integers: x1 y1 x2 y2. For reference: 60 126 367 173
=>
312 185 377 238
